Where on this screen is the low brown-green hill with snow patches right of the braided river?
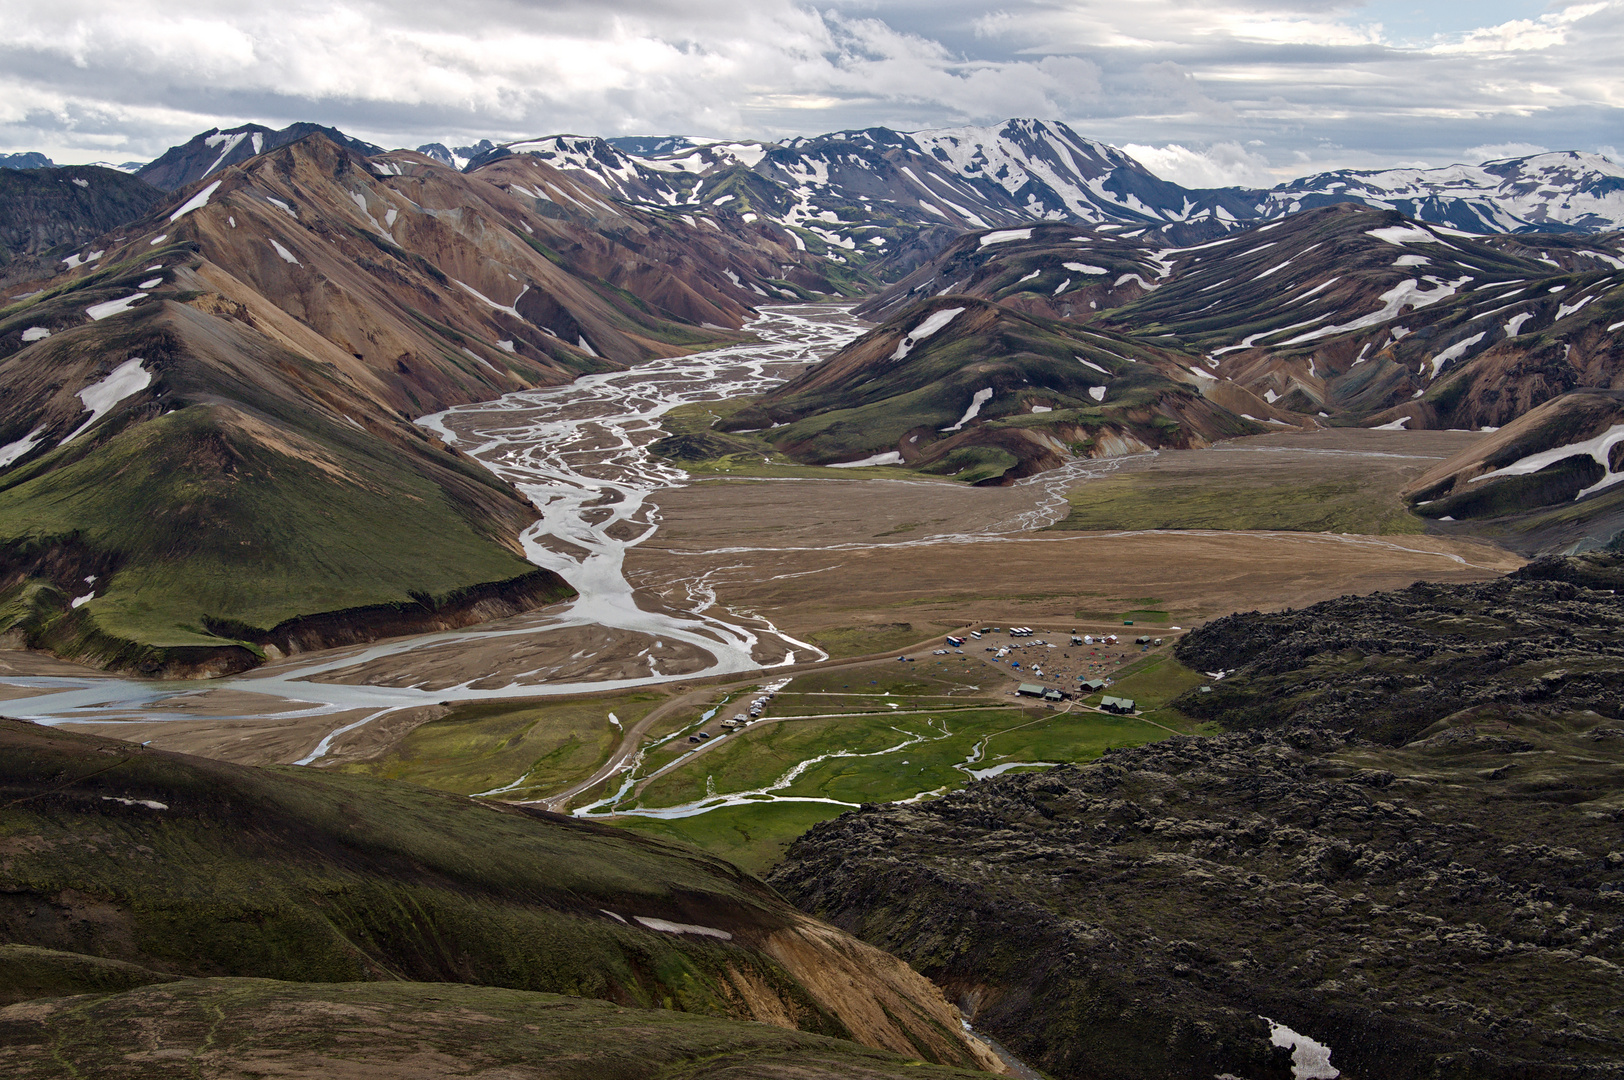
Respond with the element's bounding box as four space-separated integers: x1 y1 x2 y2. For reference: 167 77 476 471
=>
719 296 1263 484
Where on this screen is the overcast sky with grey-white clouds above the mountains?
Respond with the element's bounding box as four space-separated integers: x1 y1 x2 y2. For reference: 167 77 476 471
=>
0 0 1624 185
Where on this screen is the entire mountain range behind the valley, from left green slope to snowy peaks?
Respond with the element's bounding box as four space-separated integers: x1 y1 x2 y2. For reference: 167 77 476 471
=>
0 120 1624 674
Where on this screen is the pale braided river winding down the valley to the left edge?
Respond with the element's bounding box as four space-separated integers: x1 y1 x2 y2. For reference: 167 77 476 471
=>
0 304 866 740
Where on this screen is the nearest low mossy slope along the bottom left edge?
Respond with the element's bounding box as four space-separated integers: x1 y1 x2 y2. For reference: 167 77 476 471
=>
0 979 984 1080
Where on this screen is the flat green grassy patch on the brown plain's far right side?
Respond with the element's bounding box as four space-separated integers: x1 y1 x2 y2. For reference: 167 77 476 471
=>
1052 473 1426 534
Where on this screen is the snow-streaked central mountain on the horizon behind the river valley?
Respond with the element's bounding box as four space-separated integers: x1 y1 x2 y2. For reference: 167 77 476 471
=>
468 120 1260 270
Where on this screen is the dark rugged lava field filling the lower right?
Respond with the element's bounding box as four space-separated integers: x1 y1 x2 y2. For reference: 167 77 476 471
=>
770 557 1624 1080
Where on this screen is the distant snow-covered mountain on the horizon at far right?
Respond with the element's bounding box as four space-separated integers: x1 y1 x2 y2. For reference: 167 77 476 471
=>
1257 151 1624 234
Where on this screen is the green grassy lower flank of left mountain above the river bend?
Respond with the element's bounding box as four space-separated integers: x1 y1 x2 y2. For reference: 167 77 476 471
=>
0 406 533 645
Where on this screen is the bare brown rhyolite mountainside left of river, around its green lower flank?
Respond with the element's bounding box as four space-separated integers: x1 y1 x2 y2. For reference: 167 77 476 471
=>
0 135 837 674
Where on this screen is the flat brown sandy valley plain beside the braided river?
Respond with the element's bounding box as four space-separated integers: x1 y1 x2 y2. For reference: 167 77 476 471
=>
0 430 1523 763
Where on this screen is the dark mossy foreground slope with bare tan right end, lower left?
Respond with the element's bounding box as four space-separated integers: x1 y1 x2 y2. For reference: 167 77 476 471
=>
0 721 976 1064
